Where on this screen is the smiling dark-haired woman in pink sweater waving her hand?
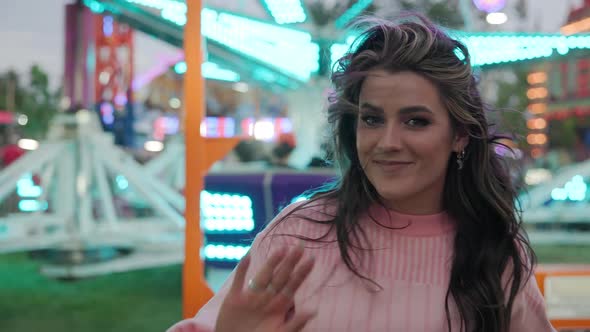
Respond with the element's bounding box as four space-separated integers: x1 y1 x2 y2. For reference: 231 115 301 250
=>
172 17 554 332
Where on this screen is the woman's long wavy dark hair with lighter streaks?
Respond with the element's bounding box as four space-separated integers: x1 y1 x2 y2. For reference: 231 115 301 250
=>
275 14 536 332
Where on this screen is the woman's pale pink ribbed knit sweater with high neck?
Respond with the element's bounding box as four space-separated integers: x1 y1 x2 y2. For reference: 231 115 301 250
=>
169 203 555 332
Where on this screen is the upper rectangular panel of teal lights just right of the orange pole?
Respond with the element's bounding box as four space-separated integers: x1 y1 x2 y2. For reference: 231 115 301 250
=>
201 190 254 233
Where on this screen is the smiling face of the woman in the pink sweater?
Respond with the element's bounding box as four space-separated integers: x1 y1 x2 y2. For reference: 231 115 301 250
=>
356 70 468 214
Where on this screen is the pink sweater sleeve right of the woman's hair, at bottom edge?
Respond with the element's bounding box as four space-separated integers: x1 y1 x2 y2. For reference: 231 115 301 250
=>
510 275 556 332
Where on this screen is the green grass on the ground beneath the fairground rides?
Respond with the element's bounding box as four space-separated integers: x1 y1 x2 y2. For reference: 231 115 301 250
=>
0 246 590 332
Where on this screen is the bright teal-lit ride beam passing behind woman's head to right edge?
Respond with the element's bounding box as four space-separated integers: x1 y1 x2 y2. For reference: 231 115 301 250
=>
331 32 590 66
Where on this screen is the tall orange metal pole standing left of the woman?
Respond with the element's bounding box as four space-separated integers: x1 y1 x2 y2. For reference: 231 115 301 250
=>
182 0 213 318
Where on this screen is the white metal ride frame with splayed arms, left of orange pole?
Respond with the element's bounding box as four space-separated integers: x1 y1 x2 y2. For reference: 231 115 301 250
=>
0 112 185 278
